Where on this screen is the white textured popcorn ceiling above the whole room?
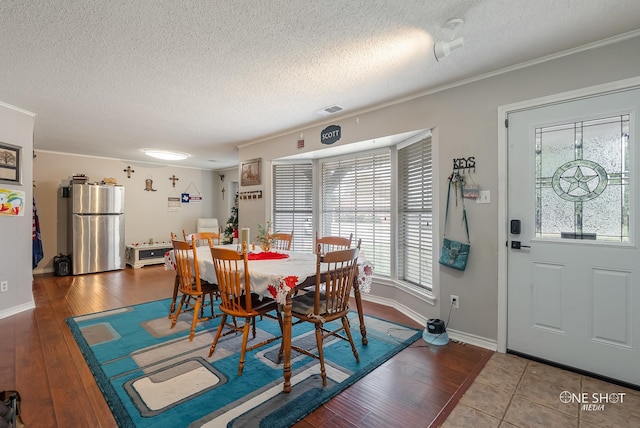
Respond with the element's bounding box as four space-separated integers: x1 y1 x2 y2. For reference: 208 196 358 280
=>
0 0 640 169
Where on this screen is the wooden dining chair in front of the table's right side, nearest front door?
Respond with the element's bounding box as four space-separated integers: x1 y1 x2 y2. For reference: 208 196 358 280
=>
291 243 360 386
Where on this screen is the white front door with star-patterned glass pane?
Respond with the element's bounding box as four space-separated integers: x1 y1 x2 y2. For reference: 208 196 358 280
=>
507 88 640 385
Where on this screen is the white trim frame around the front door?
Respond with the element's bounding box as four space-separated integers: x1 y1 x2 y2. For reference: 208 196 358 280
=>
498 77 640 353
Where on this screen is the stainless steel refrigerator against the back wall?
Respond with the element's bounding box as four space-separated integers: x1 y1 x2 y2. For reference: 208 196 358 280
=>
67 184 125 275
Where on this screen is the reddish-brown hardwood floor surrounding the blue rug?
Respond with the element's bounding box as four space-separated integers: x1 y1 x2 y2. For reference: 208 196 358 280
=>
0 266 493 428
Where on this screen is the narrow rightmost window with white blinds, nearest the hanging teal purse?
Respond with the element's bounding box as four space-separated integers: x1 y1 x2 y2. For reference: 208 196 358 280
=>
398 137 433 290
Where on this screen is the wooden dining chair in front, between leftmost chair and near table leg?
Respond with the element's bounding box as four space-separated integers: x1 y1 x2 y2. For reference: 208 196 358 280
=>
209 243 282 376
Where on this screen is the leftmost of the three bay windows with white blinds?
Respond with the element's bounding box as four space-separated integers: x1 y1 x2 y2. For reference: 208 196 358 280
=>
272 164 315 252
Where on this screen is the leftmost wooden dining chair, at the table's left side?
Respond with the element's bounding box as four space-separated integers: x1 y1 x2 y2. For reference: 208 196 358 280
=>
171 239 218 341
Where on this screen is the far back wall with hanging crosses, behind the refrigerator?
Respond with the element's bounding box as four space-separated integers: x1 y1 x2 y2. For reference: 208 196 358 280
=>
33 150 218 274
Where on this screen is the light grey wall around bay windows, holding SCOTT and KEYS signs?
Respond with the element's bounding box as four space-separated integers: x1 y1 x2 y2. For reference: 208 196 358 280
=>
239 37 640 342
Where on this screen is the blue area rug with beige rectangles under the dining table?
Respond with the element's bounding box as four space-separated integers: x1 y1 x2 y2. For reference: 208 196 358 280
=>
67 299 421 428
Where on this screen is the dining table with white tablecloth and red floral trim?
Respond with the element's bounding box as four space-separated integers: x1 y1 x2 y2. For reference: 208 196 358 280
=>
164 244 373 392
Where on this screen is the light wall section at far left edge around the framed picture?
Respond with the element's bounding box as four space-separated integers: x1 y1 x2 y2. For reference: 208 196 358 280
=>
0 103 35 318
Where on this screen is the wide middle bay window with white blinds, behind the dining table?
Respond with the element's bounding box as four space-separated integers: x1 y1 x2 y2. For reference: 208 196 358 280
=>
318 151 391 277
